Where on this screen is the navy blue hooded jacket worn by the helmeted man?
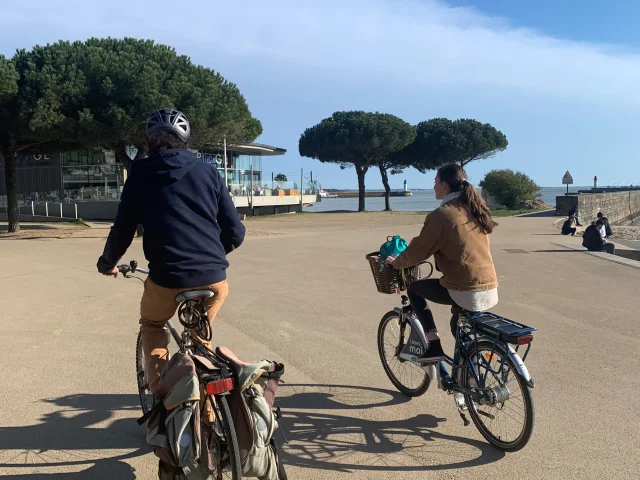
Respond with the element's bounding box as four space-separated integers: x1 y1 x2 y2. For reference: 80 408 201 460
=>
98 150 245 288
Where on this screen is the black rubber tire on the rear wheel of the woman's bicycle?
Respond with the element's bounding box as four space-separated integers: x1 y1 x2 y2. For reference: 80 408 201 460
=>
462 340 535 452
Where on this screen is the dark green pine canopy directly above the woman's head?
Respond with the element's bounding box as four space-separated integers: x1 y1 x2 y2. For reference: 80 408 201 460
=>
395 118 508 172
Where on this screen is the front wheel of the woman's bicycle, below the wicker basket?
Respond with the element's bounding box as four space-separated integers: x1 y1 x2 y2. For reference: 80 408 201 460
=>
378 311 431 397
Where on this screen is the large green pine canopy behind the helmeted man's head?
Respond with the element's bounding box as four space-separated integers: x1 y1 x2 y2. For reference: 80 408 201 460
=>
0 38 262 232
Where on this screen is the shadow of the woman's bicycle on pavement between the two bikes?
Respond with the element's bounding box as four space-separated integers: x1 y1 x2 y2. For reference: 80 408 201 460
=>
276 384 505 472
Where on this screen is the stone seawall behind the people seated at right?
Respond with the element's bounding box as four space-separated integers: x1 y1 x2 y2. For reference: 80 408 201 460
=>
556 190 640 225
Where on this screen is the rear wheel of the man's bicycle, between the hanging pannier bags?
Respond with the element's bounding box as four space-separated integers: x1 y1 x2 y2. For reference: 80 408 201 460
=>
206 395 242 480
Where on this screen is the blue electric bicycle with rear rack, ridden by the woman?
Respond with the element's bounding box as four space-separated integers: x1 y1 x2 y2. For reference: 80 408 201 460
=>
374 264 536 452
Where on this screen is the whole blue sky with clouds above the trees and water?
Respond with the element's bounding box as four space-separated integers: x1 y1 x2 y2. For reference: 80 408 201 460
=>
0 0 640 188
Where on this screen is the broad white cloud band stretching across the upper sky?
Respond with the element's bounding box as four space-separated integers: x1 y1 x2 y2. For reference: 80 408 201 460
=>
0 0 640 106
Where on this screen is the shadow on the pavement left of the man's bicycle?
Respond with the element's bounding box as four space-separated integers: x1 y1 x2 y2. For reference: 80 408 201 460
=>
0 394 148 480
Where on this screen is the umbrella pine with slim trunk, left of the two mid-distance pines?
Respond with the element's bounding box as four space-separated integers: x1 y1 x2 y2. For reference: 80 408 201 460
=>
298 111 415 211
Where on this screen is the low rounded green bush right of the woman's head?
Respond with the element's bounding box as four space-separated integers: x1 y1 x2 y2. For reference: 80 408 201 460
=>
480 170 540 208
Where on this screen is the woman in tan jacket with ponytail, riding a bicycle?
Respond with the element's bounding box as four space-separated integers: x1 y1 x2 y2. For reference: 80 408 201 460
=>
386 164 498 361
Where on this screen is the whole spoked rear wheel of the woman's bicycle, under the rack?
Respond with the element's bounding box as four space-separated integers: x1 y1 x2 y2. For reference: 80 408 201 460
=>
462 340 535 452
